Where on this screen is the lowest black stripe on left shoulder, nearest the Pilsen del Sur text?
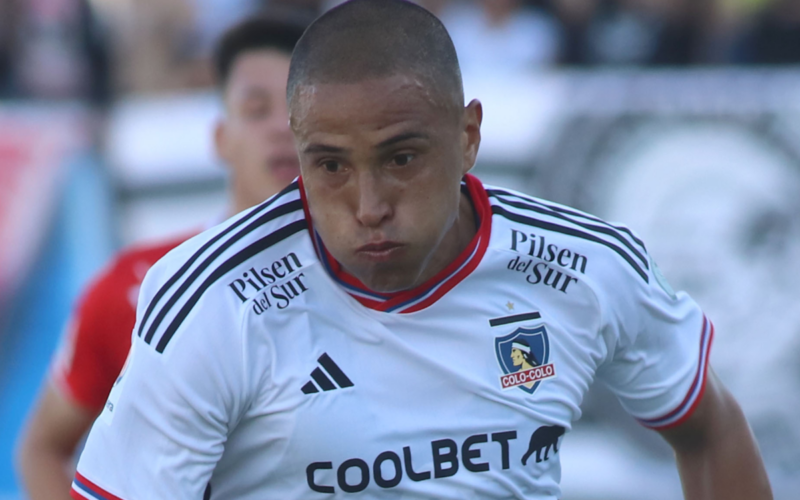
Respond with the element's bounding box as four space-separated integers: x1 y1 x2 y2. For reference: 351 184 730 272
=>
156 219 308 353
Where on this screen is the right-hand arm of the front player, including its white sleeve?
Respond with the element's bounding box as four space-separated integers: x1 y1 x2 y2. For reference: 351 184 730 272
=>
598 238 772 500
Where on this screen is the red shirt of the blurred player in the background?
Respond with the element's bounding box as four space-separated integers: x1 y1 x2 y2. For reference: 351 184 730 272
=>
52 235 188 413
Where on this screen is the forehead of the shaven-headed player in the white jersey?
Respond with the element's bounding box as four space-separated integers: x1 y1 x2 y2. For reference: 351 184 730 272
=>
290 75 452 137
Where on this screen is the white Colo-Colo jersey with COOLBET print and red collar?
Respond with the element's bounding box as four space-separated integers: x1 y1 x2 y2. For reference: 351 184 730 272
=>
73 176 712 500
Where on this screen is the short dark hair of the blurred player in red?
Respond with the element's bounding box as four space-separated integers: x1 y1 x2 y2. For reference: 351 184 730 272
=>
214 14 307 87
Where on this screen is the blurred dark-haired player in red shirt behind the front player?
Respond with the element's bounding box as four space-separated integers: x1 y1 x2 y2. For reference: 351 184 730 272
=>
19 17 303 500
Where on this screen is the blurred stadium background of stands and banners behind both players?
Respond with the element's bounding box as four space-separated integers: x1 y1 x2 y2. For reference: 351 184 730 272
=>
0 0 800 500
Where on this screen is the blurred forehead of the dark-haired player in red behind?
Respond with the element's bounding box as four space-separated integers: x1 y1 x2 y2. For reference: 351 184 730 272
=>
225 49 290 98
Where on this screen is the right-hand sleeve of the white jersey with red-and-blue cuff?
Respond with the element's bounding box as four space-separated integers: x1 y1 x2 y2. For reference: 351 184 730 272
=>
597 254 713 430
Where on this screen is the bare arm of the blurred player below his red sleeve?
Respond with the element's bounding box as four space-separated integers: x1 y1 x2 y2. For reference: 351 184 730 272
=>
17 382 95 500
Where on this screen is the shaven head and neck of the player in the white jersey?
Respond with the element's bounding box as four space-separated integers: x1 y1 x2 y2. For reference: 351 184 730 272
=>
287 0 483 293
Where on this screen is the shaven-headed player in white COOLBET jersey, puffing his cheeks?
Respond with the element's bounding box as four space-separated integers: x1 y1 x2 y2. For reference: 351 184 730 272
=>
72 0 771 500
